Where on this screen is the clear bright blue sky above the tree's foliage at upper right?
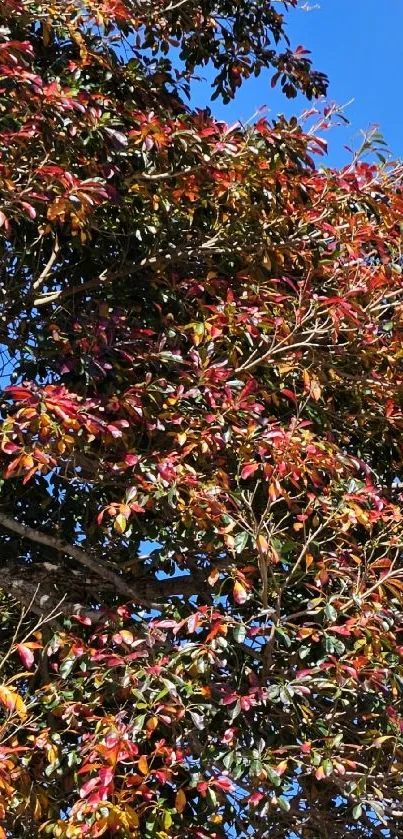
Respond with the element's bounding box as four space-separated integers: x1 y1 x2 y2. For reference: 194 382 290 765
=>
193 0 403 165
